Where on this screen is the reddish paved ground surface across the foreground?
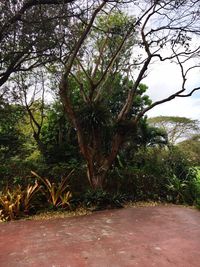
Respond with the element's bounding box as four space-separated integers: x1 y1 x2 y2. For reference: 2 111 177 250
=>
0 206 200 267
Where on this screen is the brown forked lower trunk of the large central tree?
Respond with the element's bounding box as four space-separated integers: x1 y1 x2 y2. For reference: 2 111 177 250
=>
59 71 124 190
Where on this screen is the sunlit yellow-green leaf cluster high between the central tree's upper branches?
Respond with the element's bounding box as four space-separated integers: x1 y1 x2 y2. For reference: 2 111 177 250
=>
92 10 136 73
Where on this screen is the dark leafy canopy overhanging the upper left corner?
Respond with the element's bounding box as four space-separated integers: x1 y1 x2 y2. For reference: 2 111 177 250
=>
0 0 70 87
